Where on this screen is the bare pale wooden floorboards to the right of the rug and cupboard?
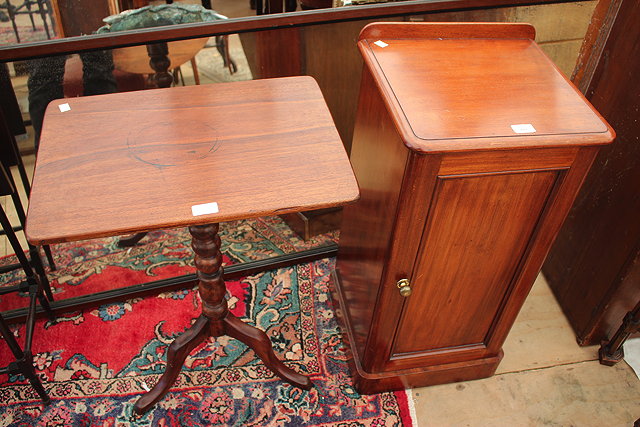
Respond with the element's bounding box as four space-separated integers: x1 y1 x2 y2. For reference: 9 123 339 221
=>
413 275 640 426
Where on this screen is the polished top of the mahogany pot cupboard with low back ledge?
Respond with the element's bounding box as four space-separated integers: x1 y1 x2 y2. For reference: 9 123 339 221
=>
359 24 614 152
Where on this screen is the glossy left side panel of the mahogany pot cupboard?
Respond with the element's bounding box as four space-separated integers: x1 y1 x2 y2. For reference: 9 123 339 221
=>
337 69 408 355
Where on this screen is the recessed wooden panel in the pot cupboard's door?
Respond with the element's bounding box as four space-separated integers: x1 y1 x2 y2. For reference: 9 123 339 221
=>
391 171 558 365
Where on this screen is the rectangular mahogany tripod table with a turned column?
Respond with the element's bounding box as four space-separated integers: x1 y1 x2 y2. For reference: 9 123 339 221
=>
27 77 358 414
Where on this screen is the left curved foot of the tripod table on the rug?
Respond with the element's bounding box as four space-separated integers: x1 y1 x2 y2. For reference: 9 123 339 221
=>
134 316 209 415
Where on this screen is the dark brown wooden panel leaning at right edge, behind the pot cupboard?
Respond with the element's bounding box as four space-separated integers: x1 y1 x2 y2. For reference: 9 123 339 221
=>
543 0 640 345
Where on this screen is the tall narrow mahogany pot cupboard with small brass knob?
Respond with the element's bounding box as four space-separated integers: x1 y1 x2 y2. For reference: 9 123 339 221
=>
334 23 614 394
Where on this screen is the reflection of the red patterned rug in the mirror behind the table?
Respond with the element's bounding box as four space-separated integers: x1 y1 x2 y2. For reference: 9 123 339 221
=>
0 216 337 311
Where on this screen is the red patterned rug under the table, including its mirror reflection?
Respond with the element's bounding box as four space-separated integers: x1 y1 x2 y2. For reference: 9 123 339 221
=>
0 218 415 426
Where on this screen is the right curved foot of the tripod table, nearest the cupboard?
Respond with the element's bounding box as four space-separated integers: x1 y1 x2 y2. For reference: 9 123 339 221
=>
222 313 313 390
